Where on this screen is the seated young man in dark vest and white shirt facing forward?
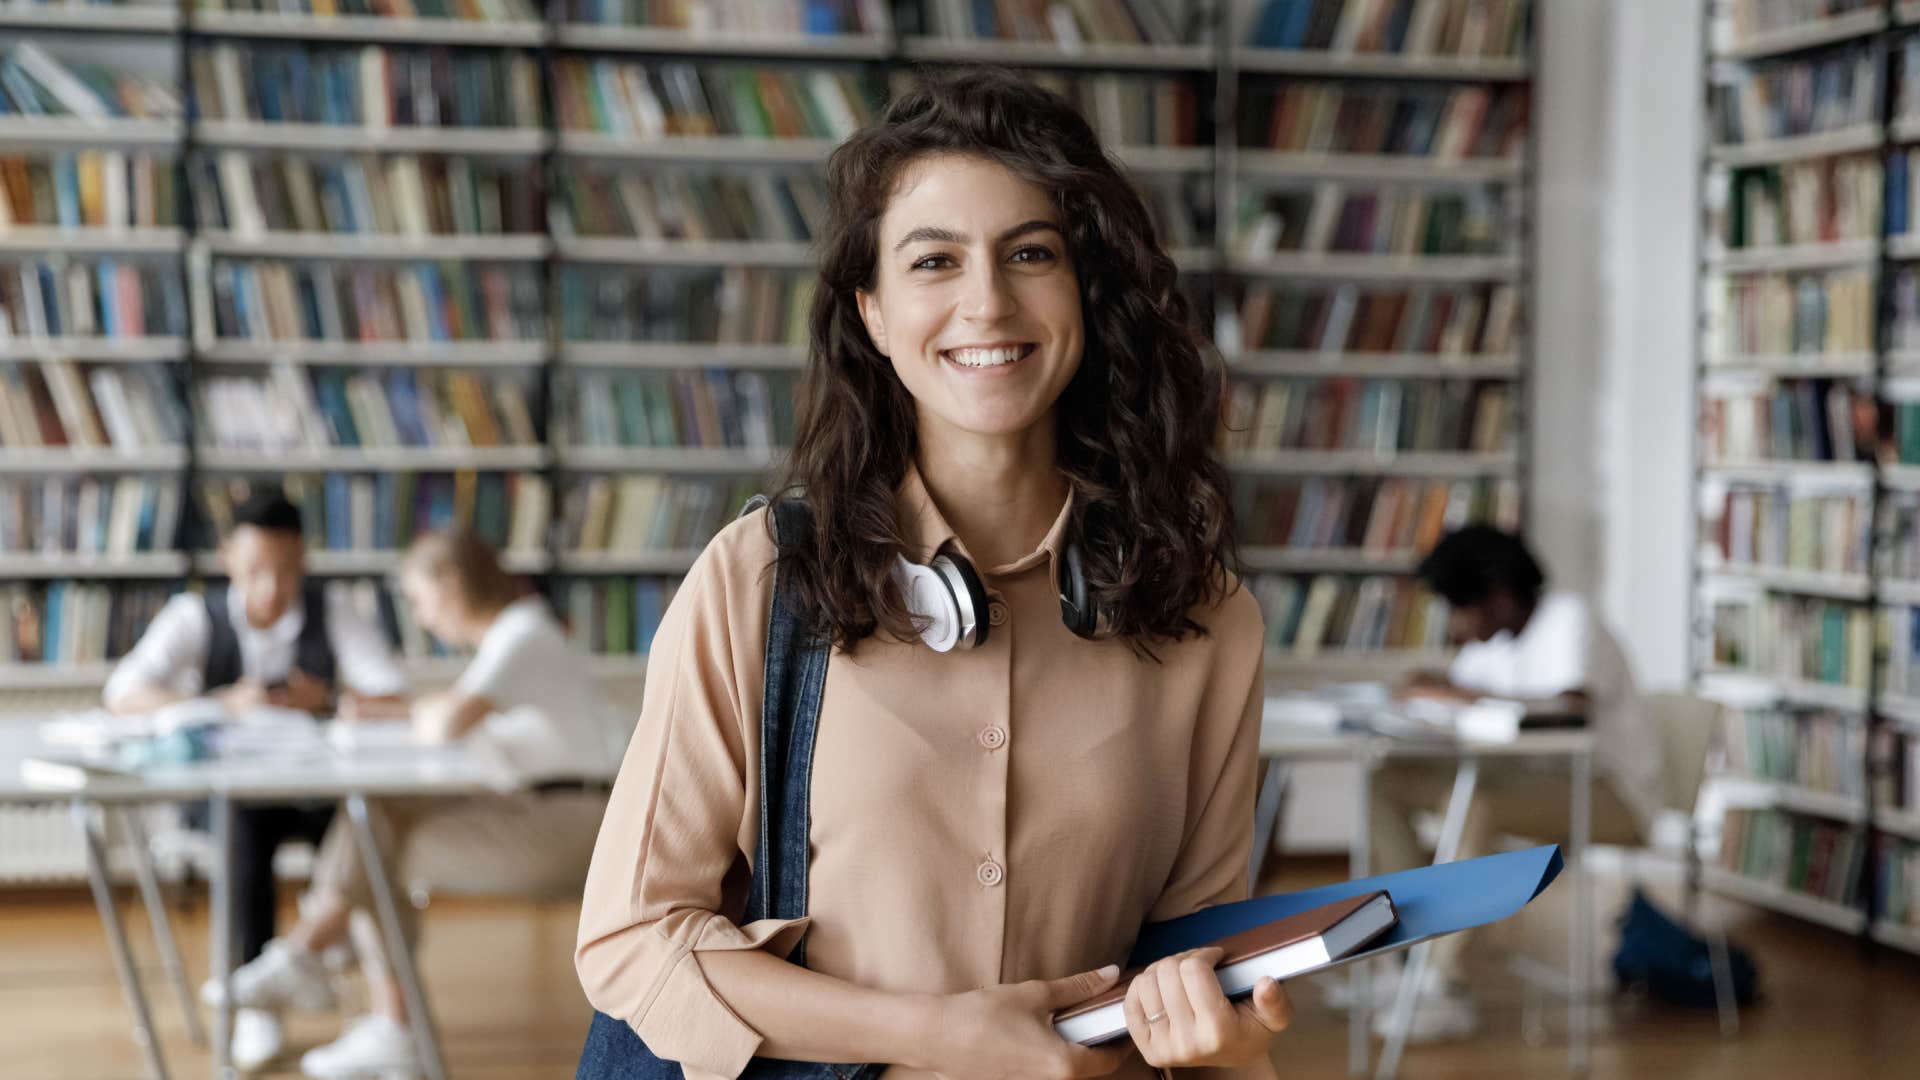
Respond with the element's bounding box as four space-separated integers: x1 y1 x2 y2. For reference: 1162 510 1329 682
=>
102 488 407 1068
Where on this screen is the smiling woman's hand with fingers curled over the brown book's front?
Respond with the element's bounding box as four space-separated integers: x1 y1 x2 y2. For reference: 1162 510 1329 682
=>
1125 949 1294 1068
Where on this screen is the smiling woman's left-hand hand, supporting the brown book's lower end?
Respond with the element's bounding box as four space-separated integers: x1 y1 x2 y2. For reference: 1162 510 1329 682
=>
929 967 1129 1080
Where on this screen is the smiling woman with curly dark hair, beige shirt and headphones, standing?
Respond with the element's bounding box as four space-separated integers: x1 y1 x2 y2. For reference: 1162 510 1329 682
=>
576 71 1288 1080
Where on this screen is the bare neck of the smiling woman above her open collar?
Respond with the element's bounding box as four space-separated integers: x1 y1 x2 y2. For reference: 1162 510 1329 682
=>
918 417 1068 569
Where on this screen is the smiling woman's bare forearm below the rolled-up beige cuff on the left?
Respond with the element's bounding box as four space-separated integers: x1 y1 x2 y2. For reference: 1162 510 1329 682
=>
699 949 939 1068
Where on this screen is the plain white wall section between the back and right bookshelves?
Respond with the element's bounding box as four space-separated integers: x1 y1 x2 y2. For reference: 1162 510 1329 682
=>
1528 0 1701 688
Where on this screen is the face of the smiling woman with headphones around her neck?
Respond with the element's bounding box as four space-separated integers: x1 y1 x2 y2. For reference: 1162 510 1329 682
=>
858 154 1085 438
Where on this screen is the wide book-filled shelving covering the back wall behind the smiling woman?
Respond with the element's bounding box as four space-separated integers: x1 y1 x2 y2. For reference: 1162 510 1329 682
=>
0 0 1536 688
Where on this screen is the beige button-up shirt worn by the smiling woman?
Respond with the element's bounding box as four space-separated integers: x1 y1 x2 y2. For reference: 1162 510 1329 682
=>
576 471 1263 1080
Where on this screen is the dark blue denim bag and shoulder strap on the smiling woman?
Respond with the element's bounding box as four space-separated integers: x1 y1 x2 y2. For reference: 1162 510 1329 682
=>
574 496 883 1080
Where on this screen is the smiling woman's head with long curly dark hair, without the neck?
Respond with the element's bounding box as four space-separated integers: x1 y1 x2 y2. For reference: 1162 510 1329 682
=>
780 71 1238 648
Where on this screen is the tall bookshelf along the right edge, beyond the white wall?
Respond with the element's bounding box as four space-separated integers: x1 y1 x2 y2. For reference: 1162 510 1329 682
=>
1693 0 1920 951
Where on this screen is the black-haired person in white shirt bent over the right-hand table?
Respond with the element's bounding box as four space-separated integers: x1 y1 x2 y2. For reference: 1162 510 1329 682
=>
1371 525 1661 1040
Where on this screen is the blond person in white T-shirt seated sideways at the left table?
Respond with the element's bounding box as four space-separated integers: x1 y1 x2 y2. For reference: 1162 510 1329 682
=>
216 532 614 1076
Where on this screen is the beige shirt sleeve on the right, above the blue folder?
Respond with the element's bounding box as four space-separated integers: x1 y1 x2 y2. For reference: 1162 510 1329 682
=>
1148 588 1265 922
